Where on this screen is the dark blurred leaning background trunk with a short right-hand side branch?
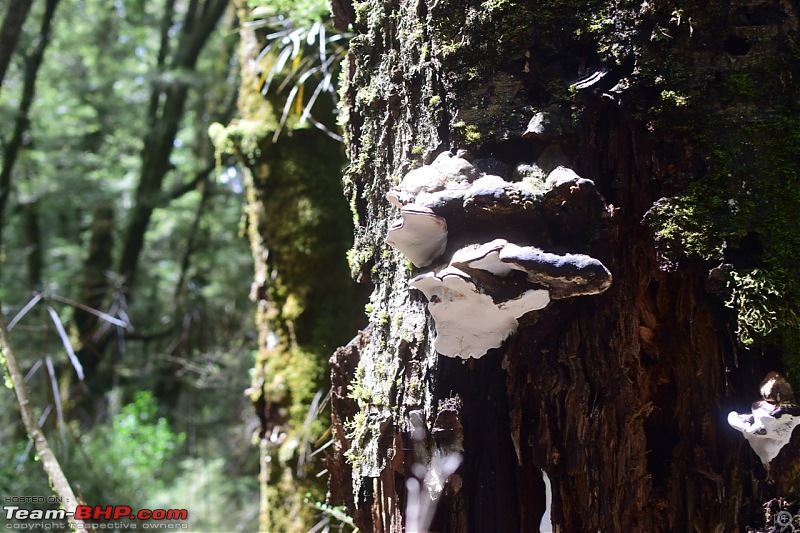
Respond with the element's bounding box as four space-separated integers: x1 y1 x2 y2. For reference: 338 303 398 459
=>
75 0 228 412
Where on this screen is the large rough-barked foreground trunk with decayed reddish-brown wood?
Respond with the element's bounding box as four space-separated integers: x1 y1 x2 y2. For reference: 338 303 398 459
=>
328 0 800 532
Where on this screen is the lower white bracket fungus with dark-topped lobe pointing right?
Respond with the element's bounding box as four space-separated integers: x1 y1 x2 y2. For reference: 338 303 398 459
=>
410 239 611 359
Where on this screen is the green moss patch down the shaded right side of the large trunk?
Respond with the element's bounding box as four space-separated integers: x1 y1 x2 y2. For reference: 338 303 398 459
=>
636 0 800 383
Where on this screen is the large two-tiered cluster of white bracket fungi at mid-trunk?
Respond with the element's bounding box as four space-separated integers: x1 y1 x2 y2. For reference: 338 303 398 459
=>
386 150 611 359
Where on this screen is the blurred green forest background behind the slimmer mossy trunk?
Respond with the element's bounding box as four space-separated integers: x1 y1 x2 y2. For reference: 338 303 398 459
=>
0 0 356 531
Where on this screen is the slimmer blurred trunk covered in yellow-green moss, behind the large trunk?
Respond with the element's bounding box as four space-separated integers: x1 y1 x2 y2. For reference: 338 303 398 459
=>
222 1 365 531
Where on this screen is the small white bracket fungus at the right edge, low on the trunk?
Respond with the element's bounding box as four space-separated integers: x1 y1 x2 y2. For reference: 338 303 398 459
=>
728 372 800 466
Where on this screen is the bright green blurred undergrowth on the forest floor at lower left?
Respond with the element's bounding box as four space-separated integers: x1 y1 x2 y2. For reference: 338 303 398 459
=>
0 392 258 531
